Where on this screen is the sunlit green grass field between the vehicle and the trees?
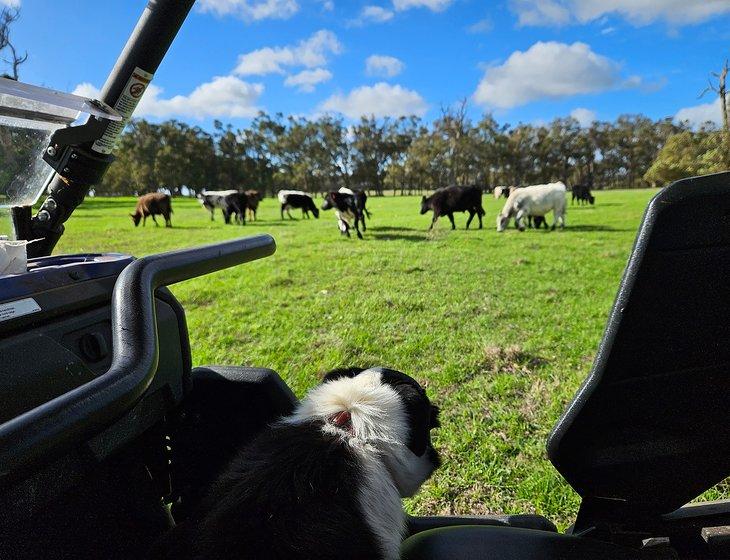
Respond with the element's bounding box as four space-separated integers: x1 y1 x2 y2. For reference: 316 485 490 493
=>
56 190 656 526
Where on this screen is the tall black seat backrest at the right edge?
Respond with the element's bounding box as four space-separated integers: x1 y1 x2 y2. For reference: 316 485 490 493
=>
548 173 730 514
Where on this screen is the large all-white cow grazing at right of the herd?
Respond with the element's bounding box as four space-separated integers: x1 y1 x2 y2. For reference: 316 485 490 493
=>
497 182 566 231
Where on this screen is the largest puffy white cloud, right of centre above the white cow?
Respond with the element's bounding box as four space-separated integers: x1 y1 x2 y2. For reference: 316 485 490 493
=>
474 41 641 109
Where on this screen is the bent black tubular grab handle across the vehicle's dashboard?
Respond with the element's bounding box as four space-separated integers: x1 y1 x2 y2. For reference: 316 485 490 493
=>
0 235 276 482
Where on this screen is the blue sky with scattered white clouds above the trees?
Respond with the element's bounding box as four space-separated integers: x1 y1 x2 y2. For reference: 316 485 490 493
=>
9 0 730 127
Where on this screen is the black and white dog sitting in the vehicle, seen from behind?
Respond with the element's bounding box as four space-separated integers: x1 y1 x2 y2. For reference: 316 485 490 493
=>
153 368 440 560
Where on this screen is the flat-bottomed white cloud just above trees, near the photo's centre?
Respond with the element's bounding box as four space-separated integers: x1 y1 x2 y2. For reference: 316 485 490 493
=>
320 82 428 119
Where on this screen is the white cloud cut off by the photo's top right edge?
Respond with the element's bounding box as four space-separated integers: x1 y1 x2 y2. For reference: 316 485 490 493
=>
510 0 730 26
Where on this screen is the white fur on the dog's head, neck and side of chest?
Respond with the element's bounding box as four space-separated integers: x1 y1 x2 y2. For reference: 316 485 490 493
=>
285 370 432 560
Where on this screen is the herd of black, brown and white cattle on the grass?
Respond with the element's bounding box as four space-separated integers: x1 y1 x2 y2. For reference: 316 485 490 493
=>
130 182 596 239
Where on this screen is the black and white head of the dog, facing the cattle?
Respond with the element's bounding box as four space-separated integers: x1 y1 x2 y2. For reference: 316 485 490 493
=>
294 368 441 498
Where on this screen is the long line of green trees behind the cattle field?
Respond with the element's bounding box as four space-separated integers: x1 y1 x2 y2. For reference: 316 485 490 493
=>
96 103 730 195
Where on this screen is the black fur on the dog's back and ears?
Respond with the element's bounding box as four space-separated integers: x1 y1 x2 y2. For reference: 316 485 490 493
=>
151 368 440 560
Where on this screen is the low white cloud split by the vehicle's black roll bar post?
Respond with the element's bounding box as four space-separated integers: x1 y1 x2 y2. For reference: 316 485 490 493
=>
73 76 264 119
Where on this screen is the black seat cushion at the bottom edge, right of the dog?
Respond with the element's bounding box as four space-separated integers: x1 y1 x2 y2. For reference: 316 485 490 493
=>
401 525 640 560
